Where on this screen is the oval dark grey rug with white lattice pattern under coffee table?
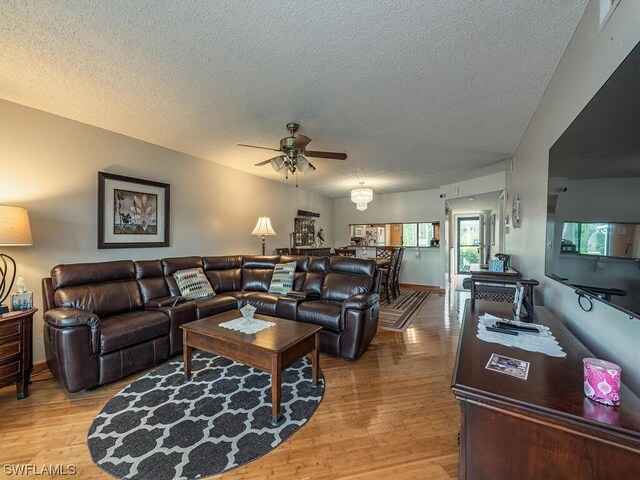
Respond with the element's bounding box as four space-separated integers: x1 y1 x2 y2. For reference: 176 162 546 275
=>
87 352 324 480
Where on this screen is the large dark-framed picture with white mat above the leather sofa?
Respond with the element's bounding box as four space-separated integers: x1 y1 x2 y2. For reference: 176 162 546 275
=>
98 172 171 249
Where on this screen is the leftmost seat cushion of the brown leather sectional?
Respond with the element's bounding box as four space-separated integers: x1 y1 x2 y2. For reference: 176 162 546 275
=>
100 310 169 354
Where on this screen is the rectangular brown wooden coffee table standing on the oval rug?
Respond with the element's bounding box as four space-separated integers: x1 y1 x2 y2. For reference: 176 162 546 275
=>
180 310 322 425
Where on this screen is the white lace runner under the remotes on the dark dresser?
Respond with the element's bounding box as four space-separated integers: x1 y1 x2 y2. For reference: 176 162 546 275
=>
478 313 567 357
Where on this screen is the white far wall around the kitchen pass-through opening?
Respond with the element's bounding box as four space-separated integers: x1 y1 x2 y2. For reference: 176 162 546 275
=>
334 189 446 288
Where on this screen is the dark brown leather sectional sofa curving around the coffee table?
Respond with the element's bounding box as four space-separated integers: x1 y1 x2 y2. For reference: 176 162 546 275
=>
42 255 380 392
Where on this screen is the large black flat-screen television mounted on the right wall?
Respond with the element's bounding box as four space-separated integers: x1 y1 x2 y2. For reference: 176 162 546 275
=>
545 43 640 318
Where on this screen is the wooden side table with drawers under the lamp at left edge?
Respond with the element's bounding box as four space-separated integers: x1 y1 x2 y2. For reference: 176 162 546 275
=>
0 308 38 400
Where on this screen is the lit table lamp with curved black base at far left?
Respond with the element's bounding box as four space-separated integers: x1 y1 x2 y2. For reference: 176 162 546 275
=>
0 205 33 314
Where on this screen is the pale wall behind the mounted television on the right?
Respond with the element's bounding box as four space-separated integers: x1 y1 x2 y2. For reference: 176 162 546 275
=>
506 0 640 390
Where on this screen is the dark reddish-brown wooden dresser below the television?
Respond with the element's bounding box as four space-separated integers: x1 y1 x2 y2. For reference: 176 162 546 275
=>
451 300 640 480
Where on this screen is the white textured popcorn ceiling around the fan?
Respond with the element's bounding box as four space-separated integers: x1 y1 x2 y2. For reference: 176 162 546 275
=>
0 0 587 197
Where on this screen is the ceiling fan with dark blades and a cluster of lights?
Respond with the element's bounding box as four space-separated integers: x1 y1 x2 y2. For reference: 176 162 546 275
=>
238 123 347 178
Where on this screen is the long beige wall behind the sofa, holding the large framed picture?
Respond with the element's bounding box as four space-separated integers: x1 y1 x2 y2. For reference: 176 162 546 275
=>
0 100 334 361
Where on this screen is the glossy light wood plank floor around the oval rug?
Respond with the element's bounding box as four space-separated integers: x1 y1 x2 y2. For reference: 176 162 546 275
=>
0 291 465 480
